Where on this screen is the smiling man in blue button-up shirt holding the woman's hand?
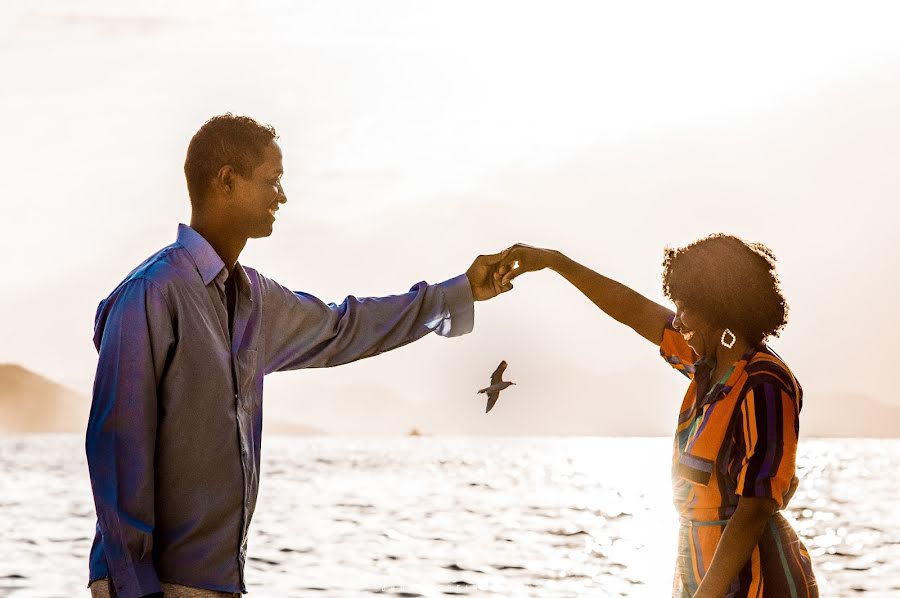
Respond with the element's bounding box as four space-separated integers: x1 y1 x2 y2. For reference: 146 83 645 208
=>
86 114 511 598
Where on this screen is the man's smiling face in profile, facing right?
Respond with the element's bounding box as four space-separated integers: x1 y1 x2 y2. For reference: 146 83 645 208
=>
228 141 287 239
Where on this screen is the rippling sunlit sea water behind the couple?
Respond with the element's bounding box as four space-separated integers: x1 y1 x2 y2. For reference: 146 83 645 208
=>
0 436 900 598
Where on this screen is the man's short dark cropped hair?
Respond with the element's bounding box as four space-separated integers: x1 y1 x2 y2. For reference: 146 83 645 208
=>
184 112 278 206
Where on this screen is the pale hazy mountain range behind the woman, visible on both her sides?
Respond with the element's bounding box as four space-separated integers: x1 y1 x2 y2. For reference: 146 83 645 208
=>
266 367 900 438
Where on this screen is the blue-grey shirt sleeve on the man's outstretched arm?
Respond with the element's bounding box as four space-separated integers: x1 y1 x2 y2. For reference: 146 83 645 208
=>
260 274 475 373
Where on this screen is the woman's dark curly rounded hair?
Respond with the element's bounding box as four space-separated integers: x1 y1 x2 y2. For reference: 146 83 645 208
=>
662 233 788 345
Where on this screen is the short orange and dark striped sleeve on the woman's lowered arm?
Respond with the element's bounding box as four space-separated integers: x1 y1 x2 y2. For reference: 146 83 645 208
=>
735 381 799 509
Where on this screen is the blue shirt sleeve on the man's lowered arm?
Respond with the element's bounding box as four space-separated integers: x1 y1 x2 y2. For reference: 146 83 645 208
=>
85 279 174 598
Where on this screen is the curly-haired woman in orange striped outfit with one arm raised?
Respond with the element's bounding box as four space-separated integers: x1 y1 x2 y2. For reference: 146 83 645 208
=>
497 234 818 598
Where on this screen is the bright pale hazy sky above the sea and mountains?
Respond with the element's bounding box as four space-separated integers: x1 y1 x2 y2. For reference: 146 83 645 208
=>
0 1 900 434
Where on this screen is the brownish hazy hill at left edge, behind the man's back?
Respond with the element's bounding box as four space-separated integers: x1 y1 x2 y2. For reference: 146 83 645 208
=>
0 364 91 434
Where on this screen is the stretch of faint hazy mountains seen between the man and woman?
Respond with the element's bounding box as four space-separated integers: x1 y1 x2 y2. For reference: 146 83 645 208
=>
258 366 685 436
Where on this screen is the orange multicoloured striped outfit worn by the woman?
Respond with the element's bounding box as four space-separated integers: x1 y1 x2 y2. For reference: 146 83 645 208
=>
660 322 819 598
